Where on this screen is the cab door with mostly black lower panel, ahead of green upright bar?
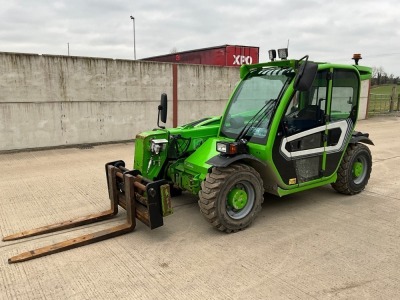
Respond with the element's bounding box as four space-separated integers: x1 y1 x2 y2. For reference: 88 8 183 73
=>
273 70 331 186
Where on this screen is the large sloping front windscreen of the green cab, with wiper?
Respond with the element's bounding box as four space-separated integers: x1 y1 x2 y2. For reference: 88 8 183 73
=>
220 67 294 143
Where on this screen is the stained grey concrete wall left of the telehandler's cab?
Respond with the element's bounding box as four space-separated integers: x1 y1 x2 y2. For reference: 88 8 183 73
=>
0 53 239 151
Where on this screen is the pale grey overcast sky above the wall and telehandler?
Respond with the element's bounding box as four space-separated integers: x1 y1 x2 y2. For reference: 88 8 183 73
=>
0 0 400 76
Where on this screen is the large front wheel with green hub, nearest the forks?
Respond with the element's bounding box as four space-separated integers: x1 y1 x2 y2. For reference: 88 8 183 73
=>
199 164 264 233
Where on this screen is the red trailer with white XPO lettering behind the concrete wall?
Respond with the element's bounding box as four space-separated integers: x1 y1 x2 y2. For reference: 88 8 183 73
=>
141 45 259 67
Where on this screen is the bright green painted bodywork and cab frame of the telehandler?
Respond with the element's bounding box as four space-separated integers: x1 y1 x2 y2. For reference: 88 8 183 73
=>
134 60 372 199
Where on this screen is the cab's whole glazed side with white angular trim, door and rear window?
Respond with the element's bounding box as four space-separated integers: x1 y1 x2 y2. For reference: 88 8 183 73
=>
273 64 360 186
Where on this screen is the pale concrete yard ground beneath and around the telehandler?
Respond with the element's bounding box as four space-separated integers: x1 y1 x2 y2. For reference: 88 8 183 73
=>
0 116 400 299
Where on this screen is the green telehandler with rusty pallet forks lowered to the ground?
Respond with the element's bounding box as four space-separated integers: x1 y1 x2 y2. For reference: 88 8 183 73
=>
3 49 373 263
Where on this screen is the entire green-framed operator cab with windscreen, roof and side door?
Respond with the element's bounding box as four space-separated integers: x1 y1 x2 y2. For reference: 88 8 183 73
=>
217 56 360 189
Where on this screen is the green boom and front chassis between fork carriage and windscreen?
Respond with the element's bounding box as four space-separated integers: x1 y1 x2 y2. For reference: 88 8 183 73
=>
134 117 221 194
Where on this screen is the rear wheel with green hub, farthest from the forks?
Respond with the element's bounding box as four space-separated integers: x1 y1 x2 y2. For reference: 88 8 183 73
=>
332 144 372 195
